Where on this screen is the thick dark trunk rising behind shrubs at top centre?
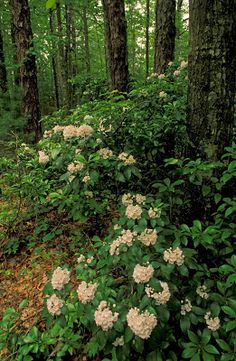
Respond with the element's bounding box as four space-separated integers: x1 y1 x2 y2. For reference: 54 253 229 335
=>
103 0 128 91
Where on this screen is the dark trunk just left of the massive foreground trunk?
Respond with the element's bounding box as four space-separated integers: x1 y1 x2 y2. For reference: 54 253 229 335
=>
154 0 176 74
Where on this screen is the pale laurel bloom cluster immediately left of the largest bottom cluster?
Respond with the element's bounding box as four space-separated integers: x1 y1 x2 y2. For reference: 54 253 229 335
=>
94 301 119 331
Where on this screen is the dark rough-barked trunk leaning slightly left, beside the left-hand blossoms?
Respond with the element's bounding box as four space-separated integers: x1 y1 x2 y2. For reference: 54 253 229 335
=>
10 0 42 141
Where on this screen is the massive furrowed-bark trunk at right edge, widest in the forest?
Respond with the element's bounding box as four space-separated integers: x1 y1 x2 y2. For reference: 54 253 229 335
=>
188 0 236 160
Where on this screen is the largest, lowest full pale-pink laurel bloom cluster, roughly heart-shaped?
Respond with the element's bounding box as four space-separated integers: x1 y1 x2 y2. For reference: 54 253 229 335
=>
127 307 157 340
